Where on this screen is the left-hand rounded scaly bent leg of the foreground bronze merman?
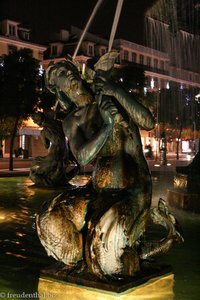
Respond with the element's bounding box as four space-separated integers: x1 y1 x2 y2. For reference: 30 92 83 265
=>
36 194 87 270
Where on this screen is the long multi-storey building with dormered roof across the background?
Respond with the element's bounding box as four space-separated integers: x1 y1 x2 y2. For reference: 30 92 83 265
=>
0 16 200 156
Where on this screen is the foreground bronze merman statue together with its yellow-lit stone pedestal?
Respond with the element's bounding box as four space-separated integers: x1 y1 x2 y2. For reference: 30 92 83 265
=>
2 1 198 299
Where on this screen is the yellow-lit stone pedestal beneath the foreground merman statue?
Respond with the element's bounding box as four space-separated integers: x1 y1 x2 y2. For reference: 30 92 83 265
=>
38 273 174 300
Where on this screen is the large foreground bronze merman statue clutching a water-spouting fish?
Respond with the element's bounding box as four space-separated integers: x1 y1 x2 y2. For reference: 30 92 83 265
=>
37 52 182 279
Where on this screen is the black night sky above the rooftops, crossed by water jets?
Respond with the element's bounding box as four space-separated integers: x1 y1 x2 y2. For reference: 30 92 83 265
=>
0 0 155 43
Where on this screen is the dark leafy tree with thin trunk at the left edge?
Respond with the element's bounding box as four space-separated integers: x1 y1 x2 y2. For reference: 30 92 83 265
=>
0 49 40 171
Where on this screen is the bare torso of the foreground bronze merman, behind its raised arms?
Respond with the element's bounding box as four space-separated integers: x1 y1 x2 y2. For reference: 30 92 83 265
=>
63 104 145 189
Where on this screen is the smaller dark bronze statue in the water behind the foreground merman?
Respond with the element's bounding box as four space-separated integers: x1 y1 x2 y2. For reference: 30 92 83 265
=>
29 112 78 187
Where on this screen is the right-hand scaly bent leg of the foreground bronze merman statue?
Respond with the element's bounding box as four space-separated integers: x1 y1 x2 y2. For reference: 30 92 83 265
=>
86 191 148 278
